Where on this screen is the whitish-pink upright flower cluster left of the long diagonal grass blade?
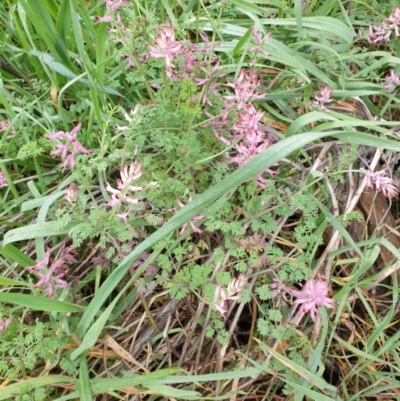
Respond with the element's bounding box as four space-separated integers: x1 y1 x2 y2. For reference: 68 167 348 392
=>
106 162 157 208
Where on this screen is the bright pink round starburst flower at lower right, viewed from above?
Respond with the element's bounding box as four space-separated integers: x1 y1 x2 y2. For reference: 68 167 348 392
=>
290 278 335 321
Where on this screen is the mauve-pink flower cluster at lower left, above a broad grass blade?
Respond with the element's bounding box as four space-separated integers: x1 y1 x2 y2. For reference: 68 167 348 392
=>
26 245 77 298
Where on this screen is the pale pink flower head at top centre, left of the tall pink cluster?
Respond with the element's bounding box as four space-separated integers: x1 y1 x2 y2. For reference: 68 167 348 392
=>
149 26 184 70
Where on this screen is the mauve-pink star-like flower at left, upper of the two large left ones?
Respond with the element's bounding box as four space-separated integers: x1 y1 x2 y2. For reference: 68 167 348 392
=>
45 123 92 172
